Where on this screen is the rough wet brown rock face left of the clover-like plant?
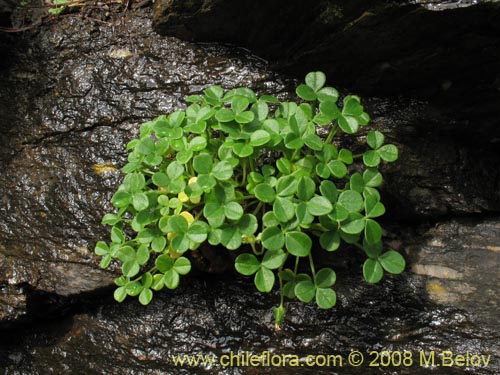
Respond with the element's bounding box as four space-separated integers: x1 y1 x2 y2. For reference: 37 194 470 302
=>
0 5 290 321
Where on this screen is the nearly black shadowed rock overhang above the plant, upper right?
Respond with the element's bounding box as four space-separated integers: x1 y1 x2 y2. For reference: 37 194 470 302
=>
153 0 500 148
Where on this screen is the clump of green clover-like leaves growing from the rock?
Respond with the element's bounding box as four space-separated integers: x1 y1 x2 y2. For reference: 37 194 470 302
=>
95 72 405 325
